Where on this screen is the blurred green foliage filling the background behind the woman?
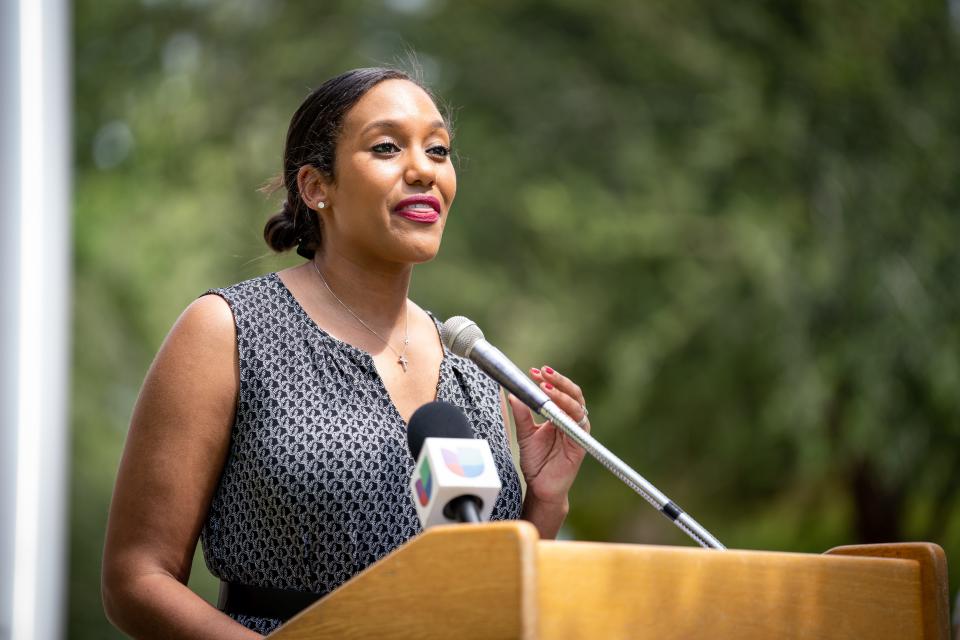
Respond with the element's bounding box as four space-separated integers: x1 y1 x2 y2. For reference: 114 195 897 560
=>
69 0 960 638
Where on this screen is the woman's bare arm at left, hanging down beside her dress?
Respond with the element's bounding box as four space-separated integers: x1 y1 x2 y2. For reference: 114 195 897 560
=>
101 296 262 639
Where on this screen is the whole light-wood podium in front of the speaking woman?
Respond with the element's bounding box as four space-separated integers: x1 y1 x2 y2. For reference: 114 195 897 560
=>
270 522 950 640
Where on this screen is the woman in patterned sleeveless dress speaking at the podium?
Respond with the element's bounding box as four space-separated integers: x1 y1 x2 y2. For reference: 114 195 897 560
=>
103 69 586 638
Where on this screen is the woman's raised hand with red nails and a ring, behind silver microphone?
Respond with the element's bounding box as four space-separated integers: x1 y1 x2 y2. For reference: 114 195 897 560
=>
509 366 590 537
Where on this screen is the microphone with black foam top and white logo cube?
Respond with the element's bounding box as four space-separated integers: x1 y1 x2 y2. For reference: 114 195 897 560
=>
407 401 501 529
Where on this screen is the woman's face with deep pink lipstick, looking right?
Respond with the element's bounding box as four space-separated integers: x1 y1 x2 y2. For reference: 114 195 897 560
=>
320 80 457 264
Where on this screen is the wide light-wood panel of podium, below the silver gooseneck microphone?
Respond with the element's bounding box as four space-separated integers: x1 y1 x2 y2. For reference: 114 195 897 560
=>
539 542 936 640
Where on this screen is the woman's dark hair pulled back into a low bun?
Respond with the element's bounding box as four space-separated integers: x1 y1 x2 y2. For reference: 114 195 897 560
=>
263 67 432 259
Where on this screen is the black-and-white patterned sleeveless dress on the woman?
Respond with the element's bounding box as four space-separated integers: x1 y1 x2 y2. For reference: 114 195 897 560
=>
201 273 521 634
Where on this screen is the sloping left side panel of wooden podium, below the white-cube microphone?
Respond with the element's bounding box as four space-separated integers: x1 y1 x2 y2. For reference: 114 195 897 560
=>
270 522 538 640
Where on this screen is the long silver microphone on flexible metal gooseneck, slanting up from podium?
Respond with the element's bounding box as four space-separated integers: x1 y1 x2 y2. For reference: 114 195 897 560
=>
440 316 726 549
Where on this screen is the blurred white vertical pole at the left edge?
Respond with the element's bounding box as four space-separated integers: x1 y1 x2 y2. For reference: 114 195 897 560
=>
0 0 71 640
